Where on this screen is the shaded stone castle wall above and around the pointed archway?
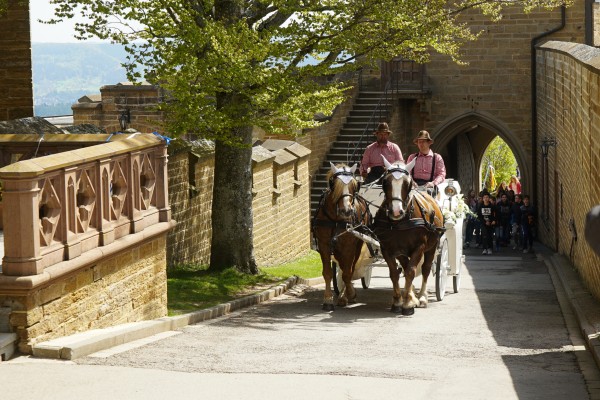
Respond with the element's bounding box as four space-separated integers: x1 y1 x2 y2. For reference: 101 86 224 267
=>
410 0 585 192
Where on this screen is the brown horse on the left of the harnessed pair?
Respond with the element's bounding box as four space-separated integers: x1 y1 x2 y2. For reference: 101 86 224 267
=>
312 164 370 311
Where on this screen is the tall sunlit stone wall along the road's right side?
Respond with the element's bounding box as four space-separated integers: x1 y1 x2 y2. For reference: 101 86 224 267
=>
537 41 600 299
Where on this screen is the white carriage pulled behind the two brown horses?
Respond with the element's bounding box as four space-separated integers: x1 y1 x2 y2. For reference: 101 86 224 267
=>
333 179 466 301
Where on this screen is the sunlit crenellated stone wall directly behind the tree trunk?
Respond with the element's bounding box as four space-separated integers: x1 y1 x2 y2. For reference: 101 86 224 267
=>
167 140 310 266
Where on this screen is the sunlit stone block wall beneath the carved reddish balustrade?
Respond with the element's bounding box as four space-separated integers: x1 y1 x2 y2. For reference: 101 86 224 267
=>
0 235 167 354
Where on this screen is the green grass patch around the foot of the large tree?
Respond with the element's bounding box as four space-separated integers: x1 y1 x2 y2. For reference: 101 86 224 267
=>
167 251 321 315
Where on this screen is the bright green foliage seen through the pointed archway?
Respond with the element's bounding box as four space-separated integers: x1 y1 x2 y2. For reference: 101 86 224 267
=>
481 136 517 191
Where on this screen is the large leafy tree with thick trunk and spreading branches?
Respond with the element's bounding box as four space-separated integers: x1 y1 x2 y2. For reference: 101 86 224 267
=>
34 0 564 273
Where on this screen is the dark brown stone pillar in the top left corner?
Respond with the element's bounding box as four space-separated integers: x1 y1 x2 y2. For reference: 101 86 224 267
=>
0 0 33 121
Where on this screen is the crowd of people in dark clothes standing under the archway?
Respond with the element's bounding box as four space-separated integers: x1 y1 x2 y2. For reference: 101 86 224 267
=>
464 176 536 254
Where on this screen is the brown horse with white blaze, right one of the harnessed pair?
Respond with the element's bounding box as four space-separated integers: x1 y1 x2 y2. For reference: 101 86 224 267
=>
373 157 444 315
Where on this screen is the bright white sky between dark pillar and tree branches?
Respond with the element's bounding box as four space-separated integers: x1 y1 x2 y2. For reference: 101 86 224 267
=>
29 0 103 43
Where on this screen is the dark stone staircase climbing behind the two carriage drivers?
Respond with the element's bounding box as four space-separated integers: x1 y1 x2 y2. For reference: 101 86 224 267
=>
310 91 392 215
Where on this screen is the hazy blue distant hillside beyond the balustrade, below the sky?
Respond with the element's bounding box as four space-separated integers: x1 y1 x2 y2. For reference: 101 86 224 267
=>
31 42 127 116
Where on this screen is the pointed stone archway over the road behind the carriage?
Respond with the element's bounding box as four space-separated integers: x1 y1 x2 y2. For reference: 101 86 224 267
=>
432 111 532 195
